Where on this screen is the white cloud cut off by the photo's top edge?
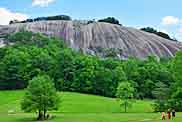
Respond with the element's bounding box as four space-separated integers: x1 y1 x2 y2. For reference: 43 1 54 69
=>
32 0 55 7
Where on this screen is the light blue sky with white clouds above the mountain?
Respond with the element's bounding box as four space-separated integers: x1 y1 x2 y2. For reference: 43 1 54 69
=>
0 0 182 41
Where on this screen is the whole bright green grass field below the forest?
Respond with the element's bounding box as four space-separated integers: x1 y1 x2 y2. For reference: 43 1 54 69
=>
0 91 182 122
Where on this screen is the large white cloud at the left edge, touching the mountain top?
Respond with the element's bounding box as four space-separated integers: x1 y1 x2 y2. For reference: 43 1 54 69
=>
0 8 28 25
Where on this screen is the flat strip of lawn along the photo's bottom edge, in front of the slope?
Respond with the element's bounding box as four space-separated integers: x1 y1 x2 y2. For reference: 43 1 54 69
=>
0 113 182 122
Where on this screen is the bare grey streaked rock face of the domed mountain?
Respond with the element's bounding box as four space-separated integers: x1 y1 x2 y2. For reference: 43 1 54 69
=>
0 21 182 58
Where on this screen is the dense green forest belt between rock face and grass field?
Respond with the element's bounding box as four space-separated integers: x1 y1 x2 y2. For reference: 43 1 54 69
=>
0 32 182 111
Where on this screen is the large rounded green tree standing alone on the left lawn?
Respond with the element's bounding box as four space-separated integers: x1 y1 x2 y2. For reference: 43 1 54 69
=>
21 75 59 120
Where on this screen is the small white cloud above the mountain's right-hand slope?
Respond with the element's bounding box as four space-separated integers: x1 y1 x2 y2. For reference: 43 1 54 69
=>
162 16 180 25
